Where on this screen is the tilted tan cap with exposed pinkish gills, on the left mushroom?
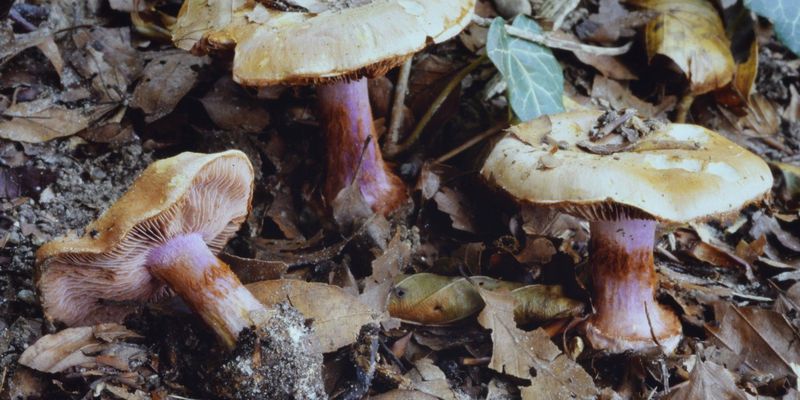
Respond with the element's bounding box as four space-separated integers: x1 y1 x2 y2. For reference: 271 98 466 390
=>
36 150 254 326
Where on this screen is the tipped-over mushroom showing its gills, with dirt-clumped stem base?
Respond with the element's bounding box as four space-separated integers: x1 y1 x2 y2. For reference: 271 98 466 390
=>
36 150 322 398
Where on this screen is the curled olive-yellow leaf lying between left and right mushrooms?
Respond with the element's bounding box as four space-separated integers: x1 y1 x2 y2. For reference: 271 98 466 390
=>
388 273 583 325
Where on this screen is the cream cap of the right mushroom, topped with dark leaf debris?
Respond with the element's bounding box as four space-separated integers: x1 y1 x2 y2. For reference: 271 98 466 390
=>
481 110 772 222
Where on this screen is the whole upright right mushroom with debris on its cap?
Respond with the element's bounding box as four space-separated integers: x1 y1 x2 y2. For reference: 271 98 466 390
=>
482 111 772 353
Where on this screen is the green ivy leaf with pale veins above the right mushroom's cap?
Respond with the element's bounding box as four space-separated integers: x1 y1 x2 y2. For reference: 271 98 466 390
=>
486 15 564 121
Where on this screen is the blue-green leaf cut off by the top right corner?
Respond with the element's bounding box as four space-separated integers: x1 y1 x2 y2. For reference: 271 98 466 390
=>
744 0 800 56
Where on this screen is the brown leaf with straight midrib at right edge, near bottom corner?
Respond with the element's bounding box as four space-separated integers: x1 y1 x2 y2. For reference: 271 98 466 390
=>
706 302 800 379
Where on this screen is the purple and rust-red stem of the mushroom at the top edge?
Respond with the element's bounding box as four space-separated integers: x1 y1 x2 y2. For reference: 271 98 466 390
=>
317 78 406 215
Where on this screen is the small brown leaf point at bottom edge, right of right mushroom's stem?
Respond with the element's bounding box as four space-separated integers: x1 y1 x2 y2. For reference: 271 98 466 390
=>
666 356 750 400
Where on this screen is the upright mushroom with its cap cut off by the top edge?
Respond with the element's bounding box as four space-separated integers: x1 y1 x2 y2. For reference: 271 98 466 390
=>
173 0 475 215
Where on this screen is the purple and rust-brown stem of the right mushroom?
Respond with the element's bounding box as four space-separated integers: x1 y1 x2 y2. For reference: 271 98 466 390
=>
585 219 681 353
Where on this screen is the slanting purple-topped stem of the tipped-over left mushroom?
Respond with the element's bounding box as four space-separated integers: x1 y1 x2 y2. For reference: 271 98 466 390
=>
147 234 266 349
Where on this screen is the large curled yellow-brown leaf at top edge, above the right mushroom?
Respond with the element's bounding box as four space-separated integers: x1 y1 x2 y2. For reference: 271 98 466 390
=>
628 0 735 95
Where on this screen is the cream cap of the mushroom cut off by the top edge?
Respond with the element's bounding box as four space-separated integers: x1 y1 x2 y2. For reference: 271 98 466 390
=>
173 0 475 87
